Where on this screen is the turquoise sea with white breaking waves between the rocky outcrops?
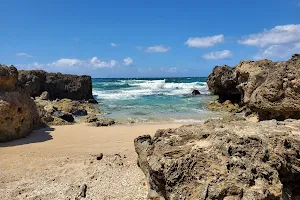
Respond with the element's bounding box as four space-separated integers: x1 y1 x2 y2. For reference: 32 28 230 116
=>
93 77 216 122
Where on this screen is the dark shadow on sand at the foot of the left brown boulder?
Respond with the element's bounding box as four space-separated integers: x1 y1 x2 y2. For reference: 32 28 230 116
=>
0 127 54 148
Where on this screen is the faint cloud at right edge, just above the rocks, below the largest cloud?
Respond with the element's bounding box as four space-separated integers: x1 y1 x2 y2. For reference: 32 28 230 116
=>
254 42 300 60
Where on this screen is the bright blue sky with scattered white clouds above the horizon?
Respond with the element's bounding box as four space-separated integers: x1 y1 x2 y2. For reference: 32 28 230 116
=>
0 0 300 78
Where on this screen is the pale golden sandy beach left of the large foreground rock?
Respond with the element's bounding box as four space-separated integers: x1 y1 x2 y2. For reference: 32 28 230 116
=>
0 124 180 200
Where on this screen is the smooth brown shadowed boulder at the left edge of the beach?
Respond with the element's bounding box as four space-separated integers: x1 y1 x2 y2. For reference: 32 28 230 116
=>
0 65 41 142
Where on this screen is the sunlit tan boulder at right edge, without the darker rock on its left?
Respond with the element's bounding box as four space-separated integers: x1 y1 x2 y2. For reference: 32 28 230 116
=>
236 55 300 120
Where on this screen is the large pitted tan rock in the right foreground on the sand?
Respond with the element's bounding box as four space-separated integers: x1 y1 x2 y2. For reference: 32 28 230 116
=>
134 117 300 200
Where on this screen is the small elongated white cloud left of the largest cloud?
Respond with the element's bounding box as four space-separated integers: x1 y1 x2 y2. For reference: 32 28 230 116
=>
184 34 224 48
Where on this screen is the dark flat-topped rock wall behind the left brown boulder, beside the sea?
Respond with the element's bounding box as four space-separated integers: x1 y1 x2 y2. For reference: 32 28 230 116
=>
18 70 93 101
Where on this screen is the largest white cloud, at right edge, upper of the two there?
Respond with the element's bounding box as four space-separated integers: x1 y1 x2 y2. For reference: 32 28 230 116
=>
238 24 300 47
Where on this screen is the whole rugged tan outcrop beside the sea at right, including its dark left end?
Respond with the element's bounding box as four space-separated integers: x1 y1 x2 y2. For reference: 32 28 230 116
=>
207 54 300 120
